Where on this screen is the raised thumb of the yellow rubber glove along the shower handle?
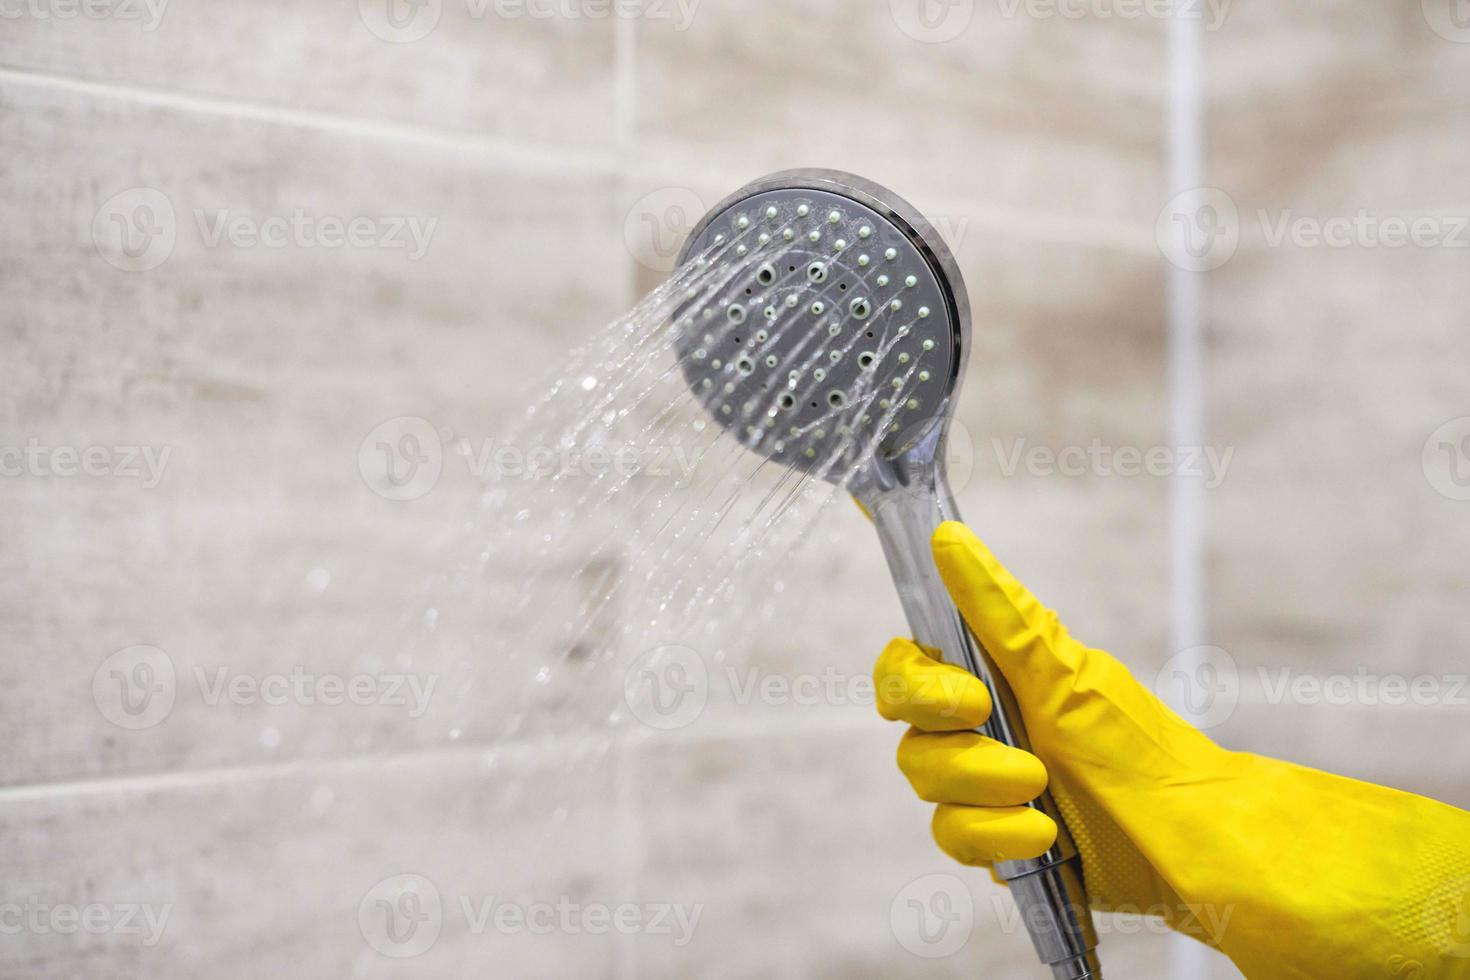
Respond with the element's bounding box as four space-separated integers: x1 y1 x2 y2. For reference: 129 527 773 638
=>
932 520 1086 708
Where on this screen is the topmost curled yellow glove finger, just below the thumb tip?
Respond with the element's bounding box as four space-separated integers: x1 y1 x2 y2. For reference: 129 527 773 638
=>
873 639 991 732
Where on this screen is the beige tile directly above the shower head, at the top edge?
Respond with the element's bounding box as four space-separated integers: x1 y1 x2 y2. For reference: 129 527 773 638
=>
638 0 1164 223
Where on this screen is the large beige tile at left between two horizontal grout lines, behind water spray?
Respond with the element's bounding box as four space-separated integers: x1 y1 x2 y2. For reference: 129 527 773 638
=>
0 84 626 782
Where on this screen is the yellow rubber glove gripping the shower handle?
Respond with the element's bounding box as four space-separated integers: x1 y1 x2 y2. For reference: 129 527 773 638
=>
875 523 1470 980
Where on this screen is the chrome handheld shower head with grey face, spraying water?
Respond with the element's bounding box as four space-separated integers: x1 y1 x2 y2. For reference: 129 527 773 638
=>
675 170 1101 980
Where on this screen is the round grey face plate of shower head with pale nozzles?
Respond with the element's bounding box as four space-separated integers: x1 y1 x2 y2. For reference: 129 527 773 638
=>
675 185 964 482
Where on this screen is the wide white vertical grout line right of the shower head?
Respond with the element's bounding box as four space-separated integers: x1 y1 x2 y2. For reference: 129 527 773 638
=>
1166 0 1213 980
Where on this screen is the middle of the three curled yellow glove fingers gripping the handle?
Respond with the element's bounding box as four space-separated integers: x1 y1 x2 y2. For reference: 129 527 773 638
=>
898 729 1047 807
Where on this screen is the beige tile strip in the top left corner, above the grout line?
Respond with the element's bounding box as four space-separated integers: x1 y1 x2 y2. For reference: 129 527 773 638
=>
0 0 617 153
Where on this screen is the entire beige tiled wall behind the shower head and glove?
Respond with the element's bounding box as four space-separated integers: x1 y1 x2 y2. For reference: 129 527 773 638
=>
0 0 1467 980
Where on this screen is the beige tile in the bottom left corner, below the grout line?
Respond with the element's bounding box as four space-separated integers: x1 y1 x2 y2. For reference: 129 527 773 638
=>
0 751 632 977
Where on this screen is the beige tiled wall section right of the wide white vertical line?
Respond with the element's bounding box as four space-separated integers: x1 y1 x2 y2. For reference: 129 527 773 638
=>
1205 1 1470 807
